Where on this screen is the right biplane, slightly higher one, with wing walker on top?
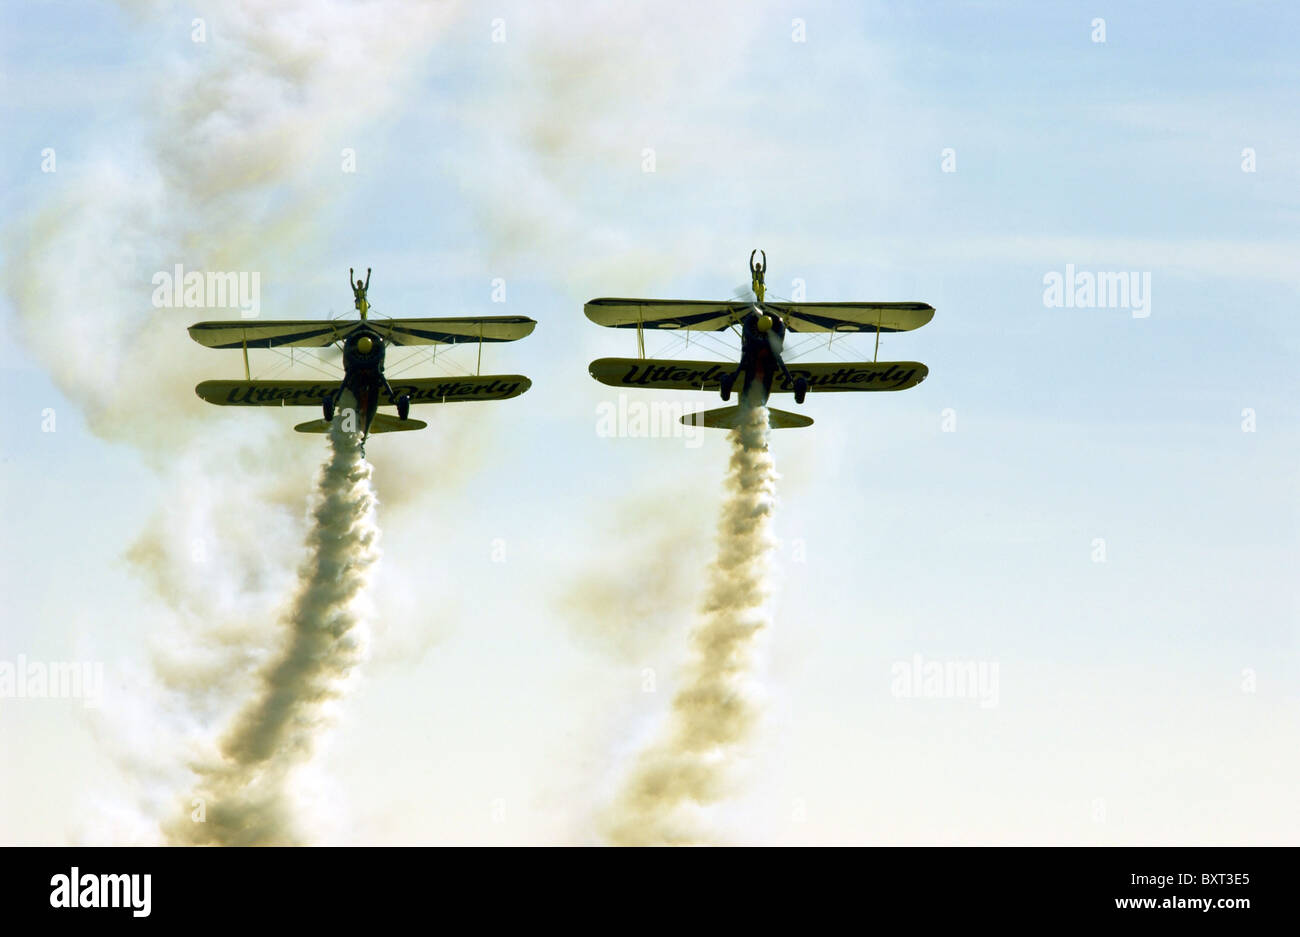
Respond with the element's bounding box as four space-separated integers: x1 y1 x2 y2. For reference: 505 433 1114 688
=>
585 251 935 429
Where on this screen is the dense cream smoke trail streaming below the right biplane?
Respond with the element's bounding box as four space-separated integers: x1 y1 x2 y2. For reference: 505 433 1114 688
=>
606 403 776 845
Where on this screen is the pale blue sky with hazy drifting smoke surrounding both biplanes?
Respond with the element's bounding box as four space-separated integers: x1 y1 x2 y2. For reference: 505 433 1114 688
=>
0 0 1300 845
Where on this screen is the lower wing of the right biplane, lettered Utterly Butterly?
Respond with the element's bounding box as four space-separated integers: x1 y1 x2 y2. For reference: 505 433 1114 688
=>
589 357 930 394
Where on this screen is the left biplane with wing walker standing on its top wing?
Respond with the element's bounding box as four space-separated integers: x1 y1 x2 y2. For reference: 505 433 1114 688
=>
190 270 537 455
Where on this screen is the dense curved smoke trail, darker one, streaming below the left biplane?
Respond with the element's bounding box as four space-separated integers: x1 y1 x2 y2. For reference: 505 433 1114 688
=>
166 429 380 845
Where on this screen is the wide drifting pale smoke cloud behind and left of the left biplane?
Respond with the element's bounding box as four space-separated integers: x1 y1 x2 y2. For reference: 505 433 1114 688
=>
0 0 456 842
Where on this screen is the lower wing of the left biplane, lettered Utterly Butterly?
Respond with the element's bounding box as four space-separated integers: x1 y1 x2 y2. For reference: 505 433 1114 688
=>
194 374 533 408
